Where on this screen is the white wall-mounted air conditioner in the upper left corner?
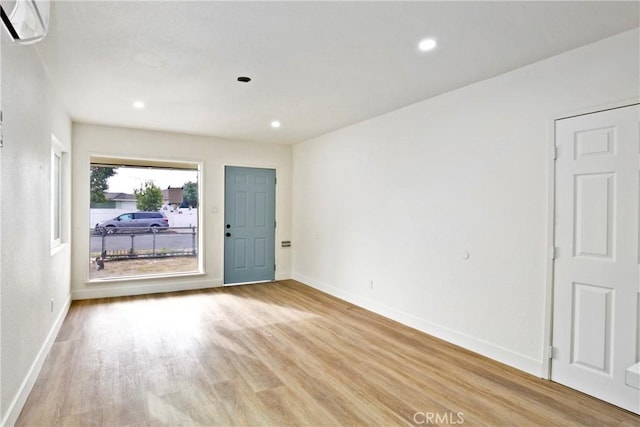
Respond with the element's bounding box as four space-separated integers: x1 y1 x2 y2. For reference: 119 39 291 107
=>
0 0 50 44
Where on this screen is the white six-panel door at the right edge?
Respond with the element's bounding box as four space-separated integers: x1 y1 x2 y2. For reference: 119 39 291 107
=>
551 105 640 414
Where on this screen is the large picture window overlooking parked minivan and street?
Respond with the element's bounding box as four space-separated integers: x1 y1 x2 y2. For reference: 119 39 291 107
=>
87 156 202 281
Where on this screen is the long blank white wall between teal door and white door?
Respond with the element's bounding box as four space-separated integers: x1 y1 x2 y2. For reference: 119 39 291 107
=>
293 30 640 376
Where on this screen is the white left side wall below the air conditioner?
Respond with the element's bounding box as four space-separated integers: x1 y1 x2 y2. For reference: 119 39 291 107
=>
0 31 71 425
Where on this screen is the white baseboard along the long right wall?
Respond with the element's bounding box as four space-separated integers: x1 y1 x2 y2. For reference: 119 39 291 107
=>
292 272 546 378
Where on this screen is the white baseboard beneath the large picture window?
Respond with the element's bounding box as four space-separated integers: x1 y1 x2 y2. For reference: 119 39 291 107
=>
71 276 222 301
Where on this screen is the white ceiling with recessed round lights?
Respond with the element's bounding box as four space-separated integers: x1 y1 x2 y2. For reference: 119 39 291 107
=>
36 1 640 143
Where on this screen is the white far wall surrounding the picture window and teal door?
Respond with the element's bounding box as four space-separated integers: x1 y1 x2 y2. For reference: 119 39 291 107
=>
71 123 292 299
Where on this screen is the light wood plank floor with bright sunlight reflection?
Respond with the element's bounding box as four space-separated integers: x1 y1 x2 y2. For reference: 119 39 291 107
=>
18 281 640 426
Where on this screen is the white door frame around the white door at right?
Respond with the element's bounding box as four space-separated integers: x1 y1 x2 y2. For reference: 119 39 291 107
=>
541 97 640 381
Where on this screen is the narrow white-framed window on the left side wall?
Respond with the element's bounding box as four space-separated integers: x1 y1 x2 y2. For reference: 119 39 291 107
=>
51 135 66 250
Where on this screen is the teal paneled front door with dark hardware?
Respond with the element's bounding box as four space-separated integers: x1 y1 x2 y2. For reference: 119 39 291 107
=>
223 166 276 284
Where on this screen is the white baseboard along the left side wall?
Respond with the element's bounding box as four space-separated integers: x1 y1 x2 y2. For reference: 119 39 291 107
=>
0 295 71 427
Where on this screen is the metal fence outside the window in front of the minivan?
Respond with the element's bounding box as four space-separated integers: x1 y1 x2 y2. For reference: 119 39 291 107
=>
90 227 198 260
